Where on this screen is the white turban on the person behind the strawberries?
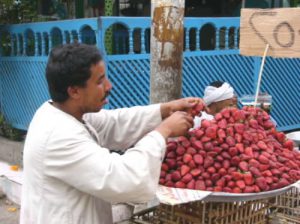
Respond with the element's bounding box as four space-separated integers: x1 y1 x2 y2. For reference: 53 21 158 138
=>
203 82 234 106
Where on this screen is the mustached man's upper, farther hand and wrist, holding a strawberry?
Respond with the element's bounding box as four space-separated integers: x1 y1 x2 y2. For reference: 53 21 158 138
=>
160 97 204 119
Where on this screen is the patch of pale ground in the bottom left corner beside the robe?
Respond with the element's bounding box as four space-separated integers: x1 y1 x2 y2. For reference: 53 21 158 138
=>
0 191 20 224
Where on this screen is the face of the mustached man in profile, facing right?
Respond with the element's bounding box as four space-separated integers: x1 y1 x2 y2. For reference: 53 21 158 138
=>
80 61 112 113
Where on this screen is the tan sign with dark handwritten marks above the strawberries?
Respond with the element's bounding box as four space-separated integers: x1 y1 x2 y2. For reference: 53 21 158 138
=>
240 8 300 58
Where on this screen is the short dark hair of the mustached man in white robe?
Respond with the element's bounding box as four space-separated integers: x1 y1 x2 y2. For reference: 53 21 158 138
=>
46 43 102 102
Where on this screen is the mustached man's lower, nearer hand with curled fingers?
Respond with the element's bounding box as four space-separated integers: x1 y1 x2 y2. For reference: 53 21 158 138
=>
155 111 194 139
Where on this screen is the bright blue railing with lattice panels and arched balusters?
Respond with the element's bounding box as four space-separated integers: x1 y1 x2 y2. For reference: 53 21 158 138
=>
0 17 300 130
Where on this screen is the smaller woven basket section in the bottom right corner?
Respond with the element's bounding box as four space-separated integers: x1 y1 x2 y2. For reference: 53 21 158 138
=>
270 188 300 224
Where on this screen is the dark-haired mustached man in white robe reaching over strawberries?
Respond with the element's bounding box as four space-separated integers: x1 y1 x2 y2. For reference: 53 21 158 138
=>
20 44 198 224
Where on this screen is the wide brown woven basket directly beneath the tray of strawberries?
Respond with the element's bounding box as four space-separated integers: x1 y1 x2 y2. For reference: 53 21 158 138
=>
132 198 274 224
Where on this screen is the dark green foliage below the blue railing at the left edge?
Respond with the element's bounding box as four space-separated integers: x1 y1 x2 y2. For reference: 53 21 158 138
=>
0 114 25 141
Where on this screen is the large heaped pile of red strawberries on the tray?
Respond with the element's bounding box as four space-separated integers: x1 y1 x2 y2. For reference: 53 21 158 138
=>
159 107 300 193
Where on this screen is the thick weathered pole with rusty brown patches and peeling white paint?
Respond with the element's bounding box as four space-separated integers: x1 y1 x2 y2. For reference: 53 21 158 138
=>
150 0 185 103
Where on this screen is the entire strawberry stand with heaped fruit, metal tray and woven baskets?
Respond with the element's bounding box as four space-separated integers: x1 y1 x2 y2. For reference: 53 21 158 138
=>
133 107 300 224
